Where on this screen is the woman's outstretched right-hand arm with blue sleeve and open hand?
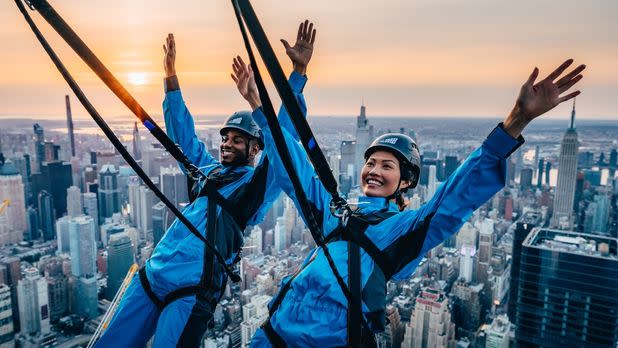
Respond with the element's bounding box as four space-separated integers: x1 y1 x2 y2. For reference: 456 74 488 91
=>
381 59 585 279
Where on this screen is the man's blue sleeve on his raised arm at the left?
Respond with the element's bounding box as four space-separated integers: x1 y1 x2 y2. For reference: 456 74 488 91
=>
163 76 217 172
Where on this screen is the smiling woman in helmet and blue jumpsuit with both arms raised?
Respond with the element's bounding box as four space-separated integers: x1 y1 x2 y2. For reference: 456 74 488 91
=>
234 53 585 347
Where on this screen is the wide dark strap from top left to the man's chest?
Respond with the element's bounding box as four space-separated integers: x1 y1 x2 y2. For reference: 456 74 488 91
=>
25 0 204 182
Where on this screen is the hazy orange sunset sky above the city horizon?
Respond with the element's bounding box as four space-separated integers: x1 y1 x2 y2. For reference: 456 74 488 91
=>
0 0 618 119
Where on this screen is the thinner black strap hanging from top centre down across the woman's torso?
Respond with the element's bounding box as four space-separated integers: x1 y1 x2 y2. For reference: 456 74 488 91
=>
232 0 350 301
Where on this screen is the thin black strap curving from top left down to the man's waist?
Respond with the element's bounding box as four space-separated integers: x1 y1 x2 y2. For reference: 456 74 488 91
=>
15 0 240 282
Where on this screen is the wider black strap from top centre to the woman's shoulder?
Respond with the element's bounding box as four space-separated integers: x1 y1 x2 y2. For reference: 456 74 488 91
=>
233 0 345 204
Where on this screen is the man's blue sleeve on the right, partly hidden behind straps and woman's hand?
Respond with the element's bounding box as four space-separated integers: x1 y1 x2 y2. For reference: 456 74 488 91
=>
243 72 307 225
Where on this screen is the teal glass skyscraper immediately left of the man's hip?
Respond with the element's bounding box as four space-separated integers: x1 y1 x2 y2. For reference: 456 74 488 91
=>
106 233 135 300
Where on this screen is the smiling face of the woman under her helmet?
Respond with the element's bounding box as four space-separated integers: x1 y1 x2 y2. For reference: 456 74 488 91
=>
361 151 410 197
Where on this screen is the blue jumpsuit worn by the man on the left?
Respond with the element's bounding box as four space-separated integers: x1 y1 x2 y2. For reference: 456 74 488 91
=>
97 73 306 348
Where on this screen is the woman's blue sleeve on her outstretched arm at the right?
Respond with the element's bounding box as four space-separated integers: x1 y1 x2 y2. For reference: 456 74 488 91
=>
394 124 524 280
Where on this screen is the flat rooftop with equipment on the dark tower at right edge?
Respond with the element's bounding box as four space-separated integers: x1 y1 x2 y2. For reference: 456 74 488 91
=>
523 228 618 260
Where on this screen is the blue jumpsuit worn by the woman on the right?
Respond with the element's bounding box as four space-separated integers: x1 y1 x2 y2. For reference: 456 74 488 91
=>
251 109 523 347
